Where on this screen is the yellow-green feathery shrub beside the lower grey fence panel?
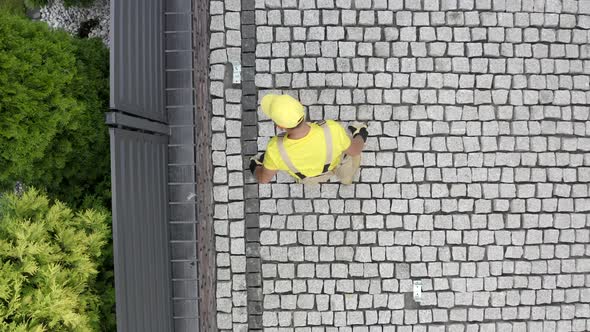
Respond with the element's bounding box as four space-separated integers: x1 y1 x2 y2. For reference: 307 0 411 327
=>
0 189 112 331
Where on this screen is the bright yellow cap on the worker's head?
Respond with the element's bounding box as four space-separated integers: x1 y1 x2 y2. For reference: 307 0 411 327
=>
260 94 305 128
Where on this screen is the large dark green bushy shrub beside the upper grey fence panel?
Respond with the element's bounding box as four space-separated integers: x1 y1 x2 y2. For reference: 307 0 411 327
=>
0 14 110 207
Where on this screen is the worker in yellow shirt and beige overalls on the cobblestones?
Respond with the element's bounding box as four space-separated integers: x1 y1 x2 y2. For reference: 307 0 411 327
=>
250 94 368 184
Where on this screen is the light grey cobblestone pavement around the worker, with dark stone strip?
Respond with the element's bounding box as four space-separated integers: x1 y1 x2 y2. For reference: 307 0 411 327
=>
211 0 590 332
